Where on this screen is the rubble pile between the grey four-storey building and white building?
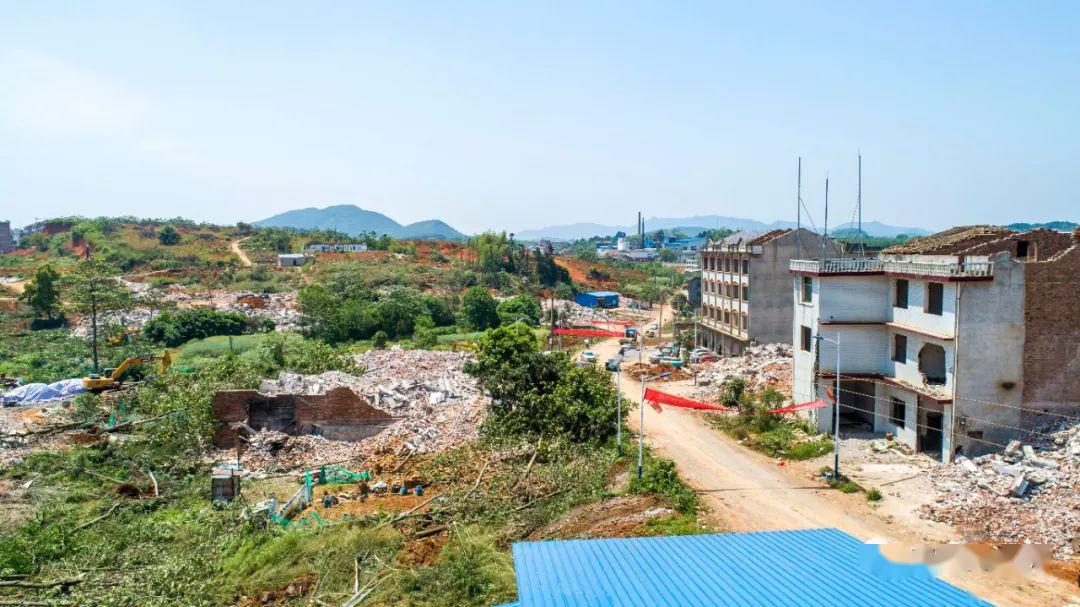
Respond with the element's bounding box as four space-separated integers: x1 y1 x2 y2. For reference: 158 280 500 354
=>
696 343 793 399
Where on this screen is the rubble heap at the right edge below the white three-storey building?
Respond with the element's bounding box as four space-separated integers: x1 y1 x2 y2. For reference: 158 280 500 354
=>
920 422 1080 558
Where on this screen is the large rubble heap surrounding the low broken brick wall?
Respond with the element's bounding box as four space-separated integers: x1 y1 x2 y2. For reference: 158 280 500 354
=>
244 350 488 469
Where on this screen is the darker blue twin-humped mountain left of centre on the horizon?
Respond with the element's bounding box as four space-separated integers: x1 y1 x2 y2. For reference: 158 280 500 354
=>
259 204 468 240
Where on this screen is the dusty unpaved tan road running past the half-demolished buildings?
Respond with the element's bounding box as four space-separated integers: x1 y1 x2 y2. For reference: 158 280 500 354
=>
592 306 1080 607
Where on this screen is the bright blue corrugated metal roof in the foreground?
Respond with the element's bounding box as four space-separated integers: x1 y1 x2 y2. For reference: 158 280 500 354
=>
513 529 990 607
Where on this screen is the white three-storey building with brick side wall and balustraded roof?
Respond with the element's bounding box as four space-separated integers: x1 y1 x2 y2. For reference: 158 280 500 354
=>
789 226 1080 461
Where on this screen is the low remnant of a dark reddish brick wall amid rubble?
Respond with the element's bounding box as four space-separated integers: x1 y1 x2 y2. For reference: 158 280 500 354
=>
212 388 394 448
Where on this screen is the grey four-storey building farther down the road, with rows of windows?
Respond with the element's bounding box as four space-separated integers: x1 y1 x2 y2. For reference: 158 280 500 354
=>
698 229 841 355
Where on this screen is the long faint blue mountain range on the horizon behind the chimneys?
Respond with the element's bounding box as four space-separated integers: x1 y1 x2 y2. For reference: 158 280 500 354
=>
515 215 930 240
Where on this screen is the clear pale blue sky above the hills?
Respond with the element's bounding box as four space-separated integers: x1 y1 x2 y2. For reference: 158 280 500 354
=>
0 0 1080 232
